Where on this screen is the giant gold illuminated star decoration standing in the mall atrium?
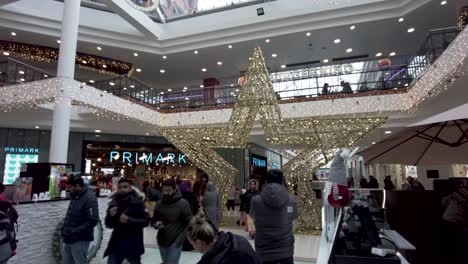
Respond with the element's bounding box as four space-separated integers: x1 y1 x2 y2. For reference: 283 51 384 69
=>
161 47 385 232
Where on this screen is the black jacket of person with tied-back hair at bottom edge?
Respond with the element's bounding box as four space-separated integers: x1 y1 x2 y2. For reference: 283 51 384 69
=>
198 232 262 264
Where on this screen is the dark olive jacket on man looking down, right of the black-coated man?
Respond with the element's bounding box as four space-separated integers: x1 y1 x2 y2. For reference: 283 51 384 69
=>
153 192 192 247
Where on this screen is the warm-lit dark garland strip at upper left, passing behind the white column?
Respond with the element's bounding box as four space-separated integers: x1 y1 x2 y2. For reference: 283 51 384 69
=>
0 40 134 76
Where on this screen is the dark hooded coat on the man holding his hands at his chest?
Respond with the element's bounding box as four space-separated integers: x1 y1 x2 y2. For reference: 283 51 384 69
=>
104 187 150 257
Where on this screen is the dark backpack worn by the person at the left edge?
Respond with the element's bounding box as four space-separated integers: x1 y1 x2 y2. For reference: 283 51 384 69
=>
0 207 18 263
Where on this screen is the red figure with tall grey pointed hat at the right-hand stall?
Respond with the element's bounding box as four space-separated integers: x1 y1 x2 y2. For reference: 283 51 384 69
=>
325 149 350 207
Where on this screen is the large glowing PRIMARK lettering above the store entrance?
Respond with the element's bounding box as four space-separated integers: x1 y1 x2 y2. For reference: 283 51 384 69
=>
110 151 187 165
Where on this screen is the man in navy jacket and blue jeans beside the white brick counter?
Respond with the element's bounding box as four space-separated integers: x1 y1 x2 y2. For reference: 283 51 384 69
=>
62 175 99 264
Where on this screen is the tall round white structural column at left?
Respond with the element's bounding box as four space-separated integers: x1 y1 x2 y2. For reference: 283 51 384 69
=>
49 0 81 163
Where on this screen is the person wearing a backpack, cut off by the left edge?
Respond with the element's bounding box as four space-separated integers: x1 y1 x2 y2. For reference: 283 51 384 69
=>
0 182 18 264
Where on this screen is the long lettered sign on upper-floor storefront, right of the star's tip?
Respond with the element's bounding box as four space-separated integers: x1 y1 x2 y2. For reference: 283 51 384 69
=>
270 64 354 82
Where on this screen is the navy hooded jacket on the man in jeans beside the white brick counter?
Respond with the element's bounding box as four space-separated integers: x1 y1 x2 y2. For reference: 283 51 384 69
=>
62 187 99 244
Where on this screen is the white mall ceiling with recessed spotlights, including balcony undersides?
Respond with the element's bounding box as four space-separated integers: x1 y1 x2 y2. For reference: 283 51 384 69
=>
0 0 467 151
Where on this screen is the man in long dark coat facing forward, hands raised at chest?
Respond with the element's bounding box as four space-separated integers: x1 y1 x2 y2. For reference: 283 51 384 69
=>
104 179 150 264
